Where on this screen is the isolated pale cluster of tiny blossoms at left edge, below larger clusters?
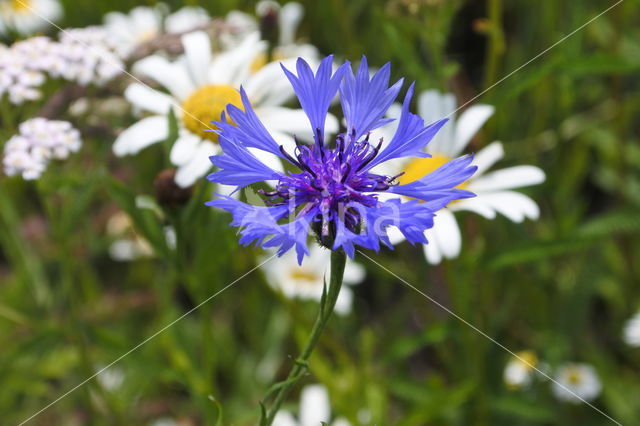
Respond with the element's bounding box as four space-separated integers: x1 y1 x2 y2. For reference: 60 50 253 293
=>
2 117 82 180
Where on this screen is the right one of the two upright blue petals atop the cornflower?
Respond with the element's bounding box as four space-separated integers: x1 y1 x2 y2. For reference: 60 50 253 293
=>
340 56 403 140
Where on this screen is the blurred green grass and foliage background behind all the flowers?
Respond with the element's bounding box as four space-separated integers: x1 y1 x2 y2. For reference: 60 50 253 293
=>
0 0 640 426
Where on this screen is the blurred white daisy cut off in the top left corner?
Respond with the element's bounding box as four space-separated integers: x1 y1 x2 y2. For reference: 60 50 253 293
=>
0 0 62 35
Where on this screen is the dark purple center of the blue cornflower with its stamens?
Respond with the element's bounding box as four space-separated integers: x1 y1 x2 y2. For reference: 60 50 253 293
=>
264 130 397 236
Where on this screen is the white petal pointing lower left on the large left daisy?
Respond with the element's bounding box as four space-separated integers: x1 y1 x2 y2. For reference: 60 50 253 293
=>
113 115 169 157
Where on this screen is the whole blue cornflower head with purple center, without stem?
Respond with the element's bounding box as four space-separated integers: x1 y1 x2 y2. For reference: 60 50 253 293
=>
207 56 476 263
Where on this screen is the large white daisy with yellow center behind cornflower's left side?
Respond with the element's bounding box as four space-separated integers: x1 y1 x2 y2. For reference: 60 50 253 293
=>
113 31 322 187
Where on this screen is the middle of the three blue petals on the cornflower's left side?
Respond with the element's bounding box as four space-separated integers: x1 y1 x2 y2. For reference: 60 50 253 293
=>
207 132 283 189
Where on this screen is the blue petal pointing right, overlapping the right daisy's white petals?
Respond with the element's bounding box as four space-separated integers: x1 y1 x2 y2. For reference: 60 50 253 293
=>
388 155 477 207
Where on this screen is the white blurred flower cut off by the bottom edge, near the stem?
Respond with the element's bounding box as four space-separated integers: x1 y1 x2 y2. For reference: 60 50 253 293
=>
273 385 351 426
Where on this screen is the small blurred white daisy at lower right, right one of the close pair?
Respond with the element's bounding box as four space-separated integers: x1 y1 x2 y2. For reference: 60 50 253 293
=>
552 364 602 403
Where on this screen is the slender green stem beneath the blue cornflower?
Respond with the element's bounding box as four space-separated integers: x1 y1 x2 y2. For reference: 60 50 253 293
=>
260 250 346 426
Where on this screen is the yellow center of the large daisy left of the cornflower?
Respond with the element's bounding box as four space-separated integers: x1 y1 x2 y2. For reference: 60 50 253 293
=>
182 84 242 142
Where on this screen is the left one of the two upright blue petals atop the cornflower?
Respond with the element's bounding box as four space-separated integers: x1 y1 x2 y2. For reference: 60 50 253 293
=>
282 55 349 144
